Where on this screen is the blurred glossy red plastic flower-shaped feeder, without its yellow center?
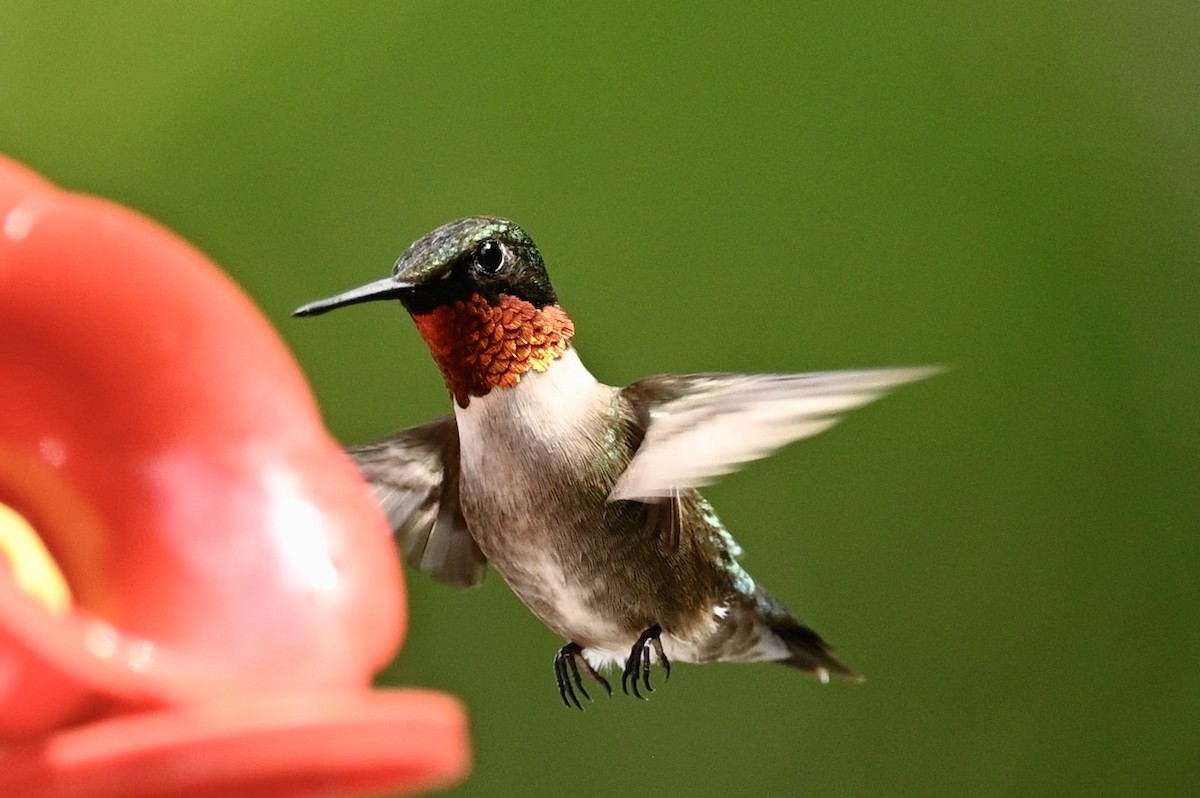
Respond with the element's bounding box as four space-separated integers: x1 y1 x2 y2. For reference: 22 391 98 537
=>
0 157 469 798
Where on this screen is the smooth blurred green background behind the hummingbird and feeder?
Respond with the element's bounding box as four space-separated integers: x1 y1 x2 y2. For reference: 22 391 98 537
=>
0 0 1200 798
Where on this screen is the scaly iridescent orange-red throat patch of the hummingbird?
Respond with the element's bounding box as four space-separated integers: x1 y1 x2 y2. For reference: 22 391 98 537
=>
413 294 575 407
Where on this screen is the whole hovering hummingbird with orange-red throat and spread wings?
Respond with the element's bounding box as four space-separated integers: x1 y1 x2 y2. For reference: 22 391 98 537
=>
294 216 937 709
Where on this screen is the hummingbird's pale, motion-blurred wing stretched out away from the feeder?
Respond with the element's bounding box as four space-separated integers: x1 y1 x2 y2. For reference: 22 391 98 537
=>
608 367 941 500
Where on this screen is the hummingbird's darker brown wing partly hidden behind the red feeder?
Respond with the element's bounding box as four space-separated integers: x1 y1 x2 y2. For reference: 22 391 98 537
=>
347 415 487 587
